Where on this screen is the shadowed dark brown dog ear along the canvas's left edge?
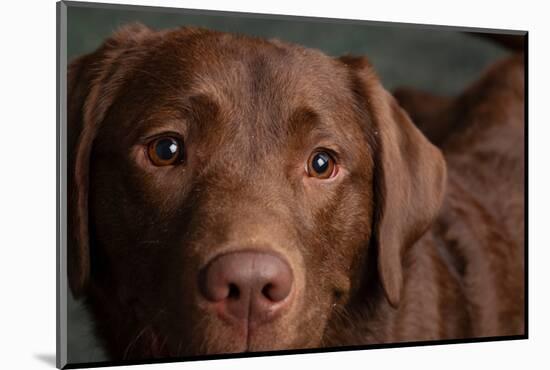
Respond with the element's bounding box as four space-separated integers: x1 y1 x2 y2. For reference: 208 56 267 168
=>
67 24 153 297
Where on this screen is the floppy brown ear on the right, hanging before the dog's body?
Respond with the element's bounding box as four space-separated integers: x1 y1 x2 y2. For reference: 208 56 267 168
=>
340 57 452 307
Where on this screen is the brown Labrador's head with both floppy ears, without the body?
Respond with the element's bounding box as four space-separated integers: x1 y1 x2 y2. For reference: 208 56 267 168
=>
69 27 445 358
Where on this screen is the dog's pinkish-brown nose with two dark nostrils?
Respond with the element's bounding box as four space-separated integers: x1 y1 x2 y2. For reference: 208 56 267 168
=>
200 251 294 325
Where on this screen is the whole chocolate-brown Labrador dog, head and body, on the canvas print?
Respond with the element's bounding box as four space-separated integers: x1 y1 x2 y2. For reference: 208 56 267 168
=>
68 25 524 360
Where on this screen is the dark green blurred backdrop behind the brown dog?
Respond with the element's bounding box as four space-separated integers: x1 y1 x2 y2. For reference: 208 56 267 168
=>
67 2 508 363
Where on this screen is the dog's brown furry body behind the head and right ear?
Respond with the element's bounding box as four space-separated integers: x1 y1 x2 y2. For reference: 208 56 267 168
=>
336 55 525 343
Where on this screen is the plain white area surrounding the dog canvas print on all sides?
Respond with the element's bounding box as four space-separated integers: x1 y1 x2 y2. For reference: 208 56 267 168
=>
0 0 550 370
